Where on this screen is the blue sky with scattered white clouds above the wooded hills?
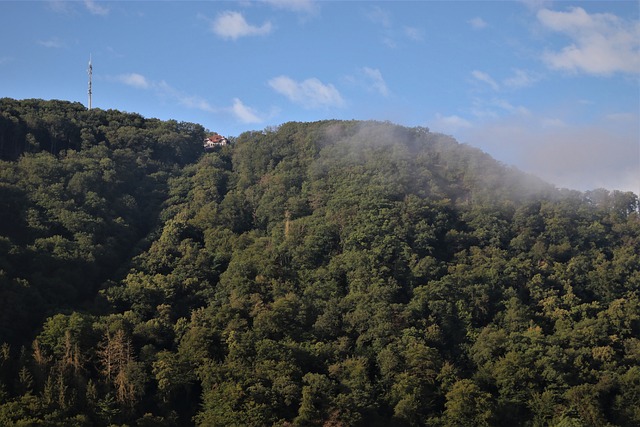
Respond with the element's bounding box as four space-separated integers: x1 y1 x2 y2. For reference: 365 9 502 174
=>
0 0 640 194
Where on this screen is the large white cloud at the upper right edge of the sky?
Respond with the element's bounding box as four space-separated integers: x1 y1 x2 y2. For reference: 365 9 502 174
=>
537 7 640 76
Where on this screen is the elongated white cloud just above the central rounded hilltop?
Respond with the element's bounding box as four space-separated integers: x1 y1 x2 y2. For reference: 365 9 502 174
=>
268 76 344 108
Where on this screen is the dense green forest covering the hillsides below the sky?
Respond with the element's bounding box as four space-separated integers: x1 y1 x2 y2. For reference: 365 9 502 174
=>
0 98 640 427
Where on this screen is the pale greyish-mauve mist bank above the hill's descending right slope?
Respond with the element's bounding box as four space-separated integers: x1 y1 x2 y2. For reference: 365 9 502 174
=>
456 115 640 194
